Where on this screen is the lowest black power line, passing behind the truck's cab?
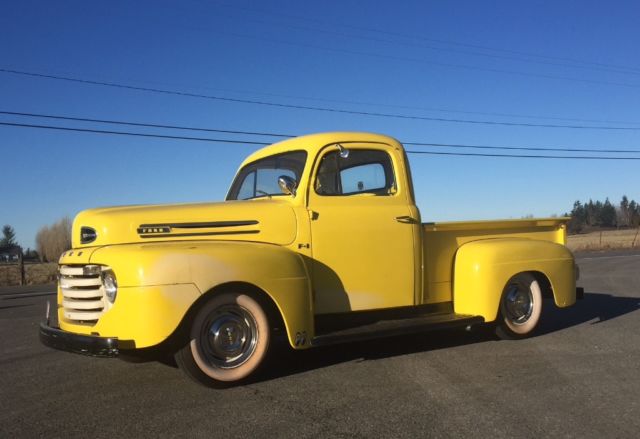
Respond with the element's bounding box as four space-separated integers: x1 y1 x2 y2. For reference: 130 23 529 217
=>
0 122 640 160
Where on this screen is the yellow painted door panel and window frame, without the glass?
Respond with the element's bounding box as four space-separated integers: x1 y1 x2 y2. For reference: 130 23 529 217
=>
309 142 420 314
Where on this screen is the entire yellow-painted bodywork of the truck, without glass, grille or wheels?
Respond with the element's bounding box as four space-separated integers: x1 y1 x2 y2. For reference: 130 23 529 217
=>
53 133 575 354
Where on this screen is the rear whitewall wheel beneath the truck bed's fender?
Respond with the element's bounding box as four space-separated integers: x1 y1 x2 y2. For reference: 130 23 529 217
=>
496 273 542 340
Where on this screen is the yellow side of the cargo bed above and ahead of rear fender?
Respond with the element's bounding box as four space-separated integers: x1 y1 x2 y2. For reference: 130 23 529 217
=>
422 218 569 304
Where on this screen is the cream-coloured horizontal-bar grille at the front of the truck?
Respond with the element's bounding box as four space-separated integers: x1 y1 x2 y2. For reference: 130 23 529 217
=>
59 265 109 324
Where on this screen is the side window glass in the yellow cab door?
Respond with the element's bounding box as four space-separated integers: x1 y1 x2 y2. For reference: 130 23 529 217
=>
315 149 395 195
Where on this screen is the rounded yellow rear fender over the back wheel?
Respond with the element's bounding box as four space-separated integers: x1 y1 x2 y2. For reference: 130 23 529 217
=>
453 238 576 322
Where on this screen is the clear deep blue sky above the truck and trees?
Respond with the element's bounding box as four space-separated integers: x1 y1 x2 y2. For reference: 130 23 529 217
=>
0 0 640 247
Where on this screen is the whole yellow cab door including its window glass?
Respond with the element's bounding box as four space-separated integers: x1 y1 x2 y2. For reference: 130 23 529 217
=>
309 144 419 314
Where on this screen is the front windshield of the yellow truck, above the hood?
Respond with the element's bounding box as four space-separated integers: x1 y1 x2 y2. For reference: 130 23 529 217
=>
227 151 307 200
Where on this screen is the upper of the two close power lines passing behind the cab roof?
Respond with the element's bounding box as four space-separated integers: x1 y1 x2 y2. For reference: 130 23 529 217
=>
5 110 640 154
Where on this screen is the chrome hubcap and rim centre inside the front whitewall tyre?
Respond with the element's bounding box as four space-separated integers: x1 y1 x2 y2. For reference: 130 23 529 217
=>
200 305 258 368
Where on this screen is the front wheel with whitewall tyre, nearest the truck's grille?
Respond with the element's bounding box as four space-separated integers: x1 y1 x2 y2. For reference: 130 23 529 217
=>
175 293 271 387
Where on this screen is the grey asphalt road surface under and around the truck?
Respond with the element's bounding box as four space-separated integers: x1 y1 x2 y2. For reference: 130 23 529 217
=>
0 252 640 438
